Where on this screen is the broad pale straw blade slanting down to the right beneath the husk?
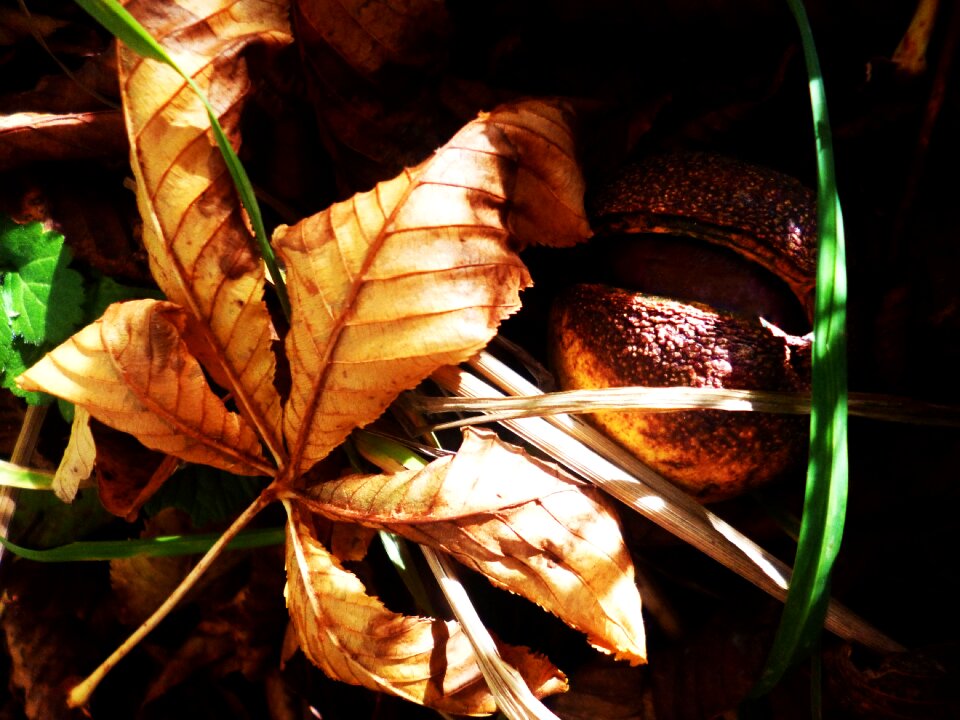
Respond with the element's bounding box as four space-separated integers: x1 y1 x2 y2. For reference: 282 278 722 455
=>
433 353 904 653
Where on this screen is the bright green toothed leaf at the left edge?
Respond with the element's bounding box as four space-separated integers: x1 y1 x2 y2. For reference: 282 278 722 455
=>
0 217 84 348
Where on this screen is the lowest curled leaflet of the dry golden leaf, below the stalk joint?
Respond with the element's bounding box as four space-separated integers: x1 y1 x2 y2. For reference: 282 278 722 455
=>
286 505 565 715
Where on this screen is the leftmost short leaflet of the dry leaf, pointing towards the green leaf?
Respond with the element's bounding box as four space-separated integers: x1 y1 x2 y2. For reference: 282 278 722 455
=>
19 300 271 475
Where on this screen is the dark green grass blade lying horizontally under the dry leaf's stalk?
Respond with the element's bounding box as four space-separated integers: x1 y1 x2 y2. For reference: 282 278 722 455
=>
0 527 285 562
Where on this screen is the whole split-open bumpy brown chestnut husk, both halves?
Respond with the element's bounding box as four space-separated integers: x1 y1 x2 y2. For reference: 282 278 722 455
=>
550 153 816 501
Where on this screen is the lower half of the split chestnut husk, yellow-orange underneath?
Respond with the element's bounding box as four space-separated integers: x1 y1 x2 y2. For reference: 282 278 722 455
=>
550 285 810 501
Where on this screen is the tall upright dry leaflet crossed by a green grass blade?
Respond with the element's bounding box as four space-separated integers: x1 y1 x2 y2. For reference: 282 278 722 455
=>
120 0 290 458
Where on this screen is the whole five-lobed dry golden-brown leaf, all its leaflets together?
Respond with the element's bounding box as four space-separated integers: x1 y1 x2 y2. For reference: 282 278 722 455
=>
11 1 645 714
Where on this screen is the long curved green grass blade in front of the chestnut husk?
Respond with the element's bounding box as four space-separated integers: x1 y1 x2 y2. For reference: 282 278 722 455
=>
754 0 848 695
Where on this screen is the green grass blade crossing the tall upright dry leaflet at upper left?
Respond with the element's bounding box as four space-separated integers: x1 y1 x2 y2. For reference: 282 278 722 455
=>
74 0 290 318
